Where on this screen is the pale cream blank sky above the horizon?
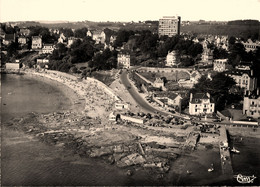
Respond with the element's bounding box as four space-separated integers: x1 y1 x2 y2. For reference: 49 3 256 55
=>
0 0 260 22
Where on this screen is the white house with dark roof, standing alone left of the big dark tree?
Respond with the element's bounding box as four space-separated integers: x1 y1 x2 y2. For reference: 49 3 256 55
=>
189 93 215 115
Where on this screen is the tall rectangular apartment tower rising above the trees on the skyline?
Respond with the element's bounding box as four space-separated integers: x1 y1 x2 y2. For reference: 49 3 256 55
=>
158 16 181 37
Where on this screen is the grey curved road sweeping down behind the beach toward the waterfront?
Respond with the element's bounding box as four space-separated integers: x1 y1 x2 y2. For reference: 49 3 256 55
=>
120 70 169 115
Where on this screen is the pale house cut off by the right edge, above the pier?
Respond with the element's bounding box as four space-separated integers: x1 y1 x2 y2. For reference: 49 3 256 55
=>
243 88 260 118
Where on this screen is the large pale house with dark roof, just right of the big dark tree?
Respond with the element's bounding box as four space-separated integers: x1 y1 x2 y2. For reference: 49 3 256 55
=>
226 70 257 91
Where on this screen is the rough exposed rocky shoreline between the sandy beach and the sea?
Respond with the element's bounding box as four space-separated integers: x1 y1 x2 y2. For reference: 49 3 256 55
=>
3 111 192 178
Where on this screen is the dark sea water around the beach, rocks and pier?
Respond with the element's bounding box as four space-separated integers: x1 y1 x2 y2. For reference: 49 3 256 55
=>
0 74 260 186
